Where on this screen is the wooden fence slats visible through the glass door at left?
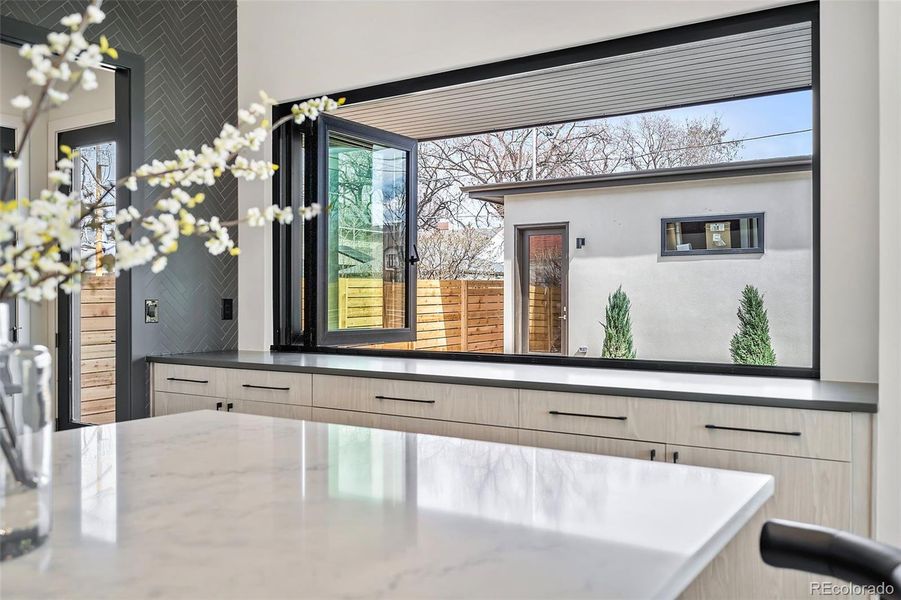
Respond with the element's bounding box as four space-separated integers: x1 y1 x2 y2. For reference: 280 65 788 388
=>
76 275 116 425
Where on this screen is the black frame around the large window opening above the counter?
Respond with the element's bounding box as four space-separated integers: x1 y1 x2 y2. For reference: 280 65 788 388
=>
271 1 821 379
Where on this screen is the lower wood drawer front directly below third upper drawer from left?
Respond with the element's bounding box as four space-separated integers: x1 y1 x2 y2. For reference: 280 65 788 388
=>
313 408 517 444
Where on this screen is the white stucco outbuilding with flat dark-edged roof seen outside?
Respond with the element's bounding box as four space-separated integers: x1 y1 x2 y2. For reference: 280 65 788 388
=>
467 158 815 367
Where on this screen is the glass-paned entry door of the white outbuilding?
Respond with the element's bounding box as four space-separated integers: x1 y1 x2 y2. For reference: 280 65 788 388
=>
517 225 569 355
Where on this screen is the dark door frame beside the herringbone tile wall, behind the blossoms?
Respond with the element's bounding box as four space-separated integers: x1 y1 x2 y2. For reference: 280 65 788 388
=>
0 17 147 428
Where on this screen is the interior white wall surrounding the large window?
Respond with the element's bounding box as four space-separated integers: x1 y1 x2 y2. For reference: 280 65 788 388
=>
238 0 878 382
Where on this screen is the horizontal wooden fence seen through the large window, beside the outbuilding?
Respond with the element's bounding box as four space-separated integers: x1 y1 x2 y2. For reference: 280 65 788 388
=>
338 278 504 353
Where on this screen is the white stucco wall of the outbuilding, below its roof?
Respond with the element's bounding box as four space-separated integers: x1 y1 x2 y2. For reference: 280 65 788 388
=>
504 171 813 367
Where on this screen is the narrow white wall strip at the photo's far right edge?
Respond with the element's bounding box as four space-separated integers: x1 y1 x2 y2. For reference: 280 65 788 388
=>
875 0 901 547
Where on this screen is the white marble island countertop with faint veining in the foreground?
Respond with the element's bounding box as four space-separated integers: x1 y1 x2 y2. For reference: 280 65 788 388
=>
0 411 773 600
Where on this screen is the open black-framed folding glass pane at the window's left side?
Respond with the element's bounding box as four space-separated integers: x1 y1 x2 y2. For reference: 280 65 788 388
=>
314 116 419 345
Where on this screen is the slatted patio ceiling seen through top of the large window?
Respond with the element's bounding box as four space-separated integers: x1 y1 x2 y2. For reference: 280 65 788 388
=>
337 23 811 140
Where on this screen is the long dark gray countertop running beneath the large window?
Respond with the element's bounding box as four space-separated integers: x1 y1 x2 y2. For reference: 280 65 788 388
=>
147 351 878 413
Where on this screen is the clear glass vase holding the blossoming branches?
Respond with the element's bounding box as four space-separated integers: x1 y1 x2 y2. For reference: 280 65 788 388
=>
0 303 53 561
